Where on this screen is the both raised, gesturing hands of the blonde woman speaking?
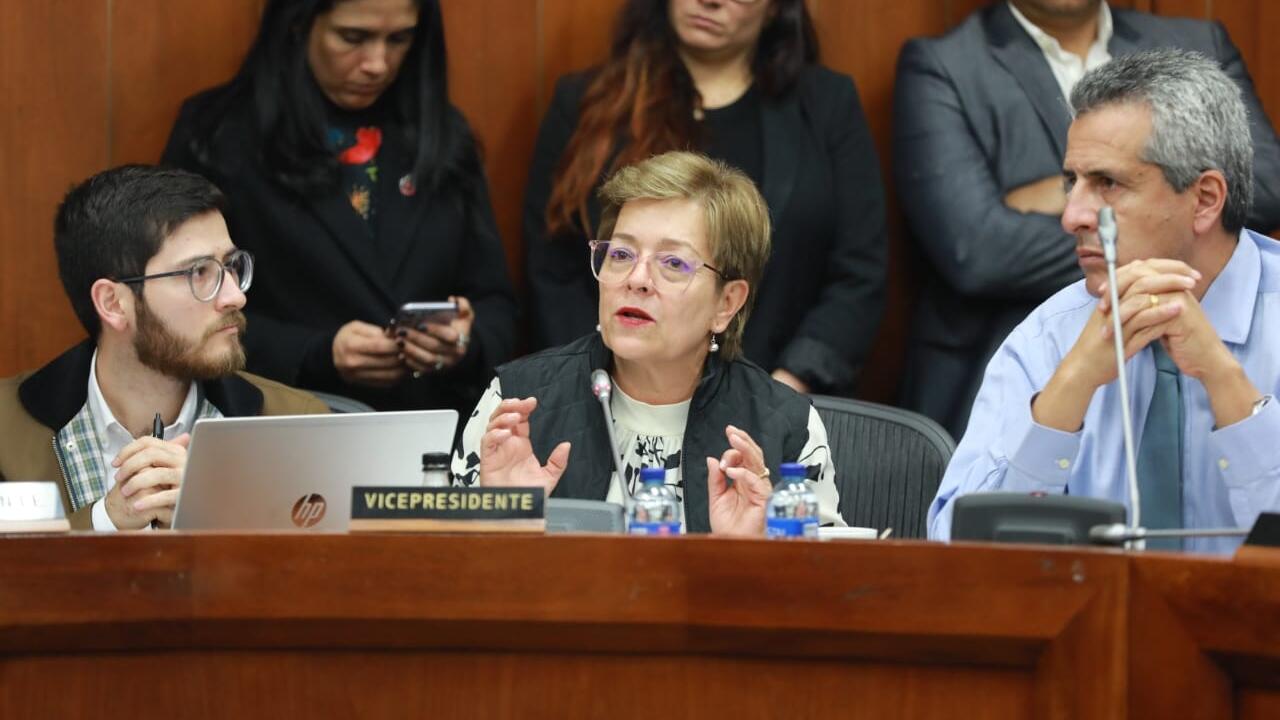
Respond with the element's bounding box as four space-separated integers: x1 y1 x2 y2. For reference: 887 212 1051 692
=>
480 397 773 537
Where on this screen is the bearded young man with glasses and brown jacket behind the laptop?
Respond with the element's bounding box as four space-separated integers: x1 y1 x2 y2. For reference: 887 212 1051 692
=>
0 165 328 530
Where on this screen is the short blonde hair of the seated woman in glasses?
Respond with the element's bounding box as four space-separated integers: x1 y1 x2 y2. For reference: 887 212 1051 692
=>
599 151 772 360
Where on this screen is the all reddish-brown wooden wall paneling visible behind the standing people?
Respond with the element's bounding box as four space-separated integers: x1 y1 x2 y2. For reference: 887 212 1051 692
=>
10 0 1280 401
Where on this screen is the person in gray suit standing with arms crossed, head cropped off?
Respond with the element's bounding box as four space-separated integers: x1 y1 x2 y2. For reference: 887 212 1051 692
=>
893 0 1280 439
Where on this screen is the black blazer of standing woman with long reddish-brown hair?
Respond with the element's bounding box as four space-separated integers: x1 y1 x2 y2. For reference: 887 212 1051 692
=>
524 67 886 392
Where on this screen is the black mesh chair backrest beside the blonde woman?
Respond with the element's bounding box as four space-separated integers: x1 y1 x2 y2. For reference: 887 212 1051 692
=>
810 395 956 538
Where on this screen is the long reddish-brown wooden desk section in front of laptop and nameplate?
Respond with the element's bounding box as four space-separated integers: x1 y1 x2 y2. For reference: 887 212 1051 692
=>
0 533 1131 719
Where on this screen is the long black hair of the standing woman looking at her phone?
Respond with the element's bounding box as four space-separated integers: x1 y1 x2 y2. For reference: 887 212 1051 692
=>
184 0 480 193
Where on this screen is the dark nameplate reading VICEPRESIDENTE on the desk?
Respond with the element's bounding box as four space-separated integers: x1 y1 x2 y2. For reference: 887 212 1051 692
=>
348 486 547 533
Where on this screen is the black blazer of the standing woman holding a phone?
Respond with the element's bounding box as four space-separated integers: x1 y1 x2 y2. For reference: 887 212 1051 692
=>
163 90 516 413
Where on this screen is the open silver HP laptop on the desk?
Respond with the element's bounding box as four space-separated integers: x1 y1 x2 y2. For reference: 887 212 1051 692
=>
173 410 458 533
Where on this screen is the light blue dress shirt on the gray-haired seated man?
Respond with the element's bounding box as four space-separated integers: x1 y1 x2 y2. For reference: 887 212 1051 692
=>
929 231 1280 552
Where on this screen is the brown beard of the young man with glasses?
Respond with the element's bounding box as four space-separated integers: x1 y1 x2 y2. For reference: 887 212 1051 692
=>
133 301 248 380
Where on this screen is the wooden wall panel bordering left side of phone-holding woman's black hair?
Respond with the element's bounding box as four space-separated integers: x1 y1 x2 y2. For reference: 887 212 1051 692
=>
109 0 262 165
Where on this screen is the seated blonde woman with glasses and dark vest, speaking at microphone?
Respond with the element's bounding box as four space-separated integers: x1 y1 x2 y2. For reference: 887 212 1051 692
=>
453 152 845 536
